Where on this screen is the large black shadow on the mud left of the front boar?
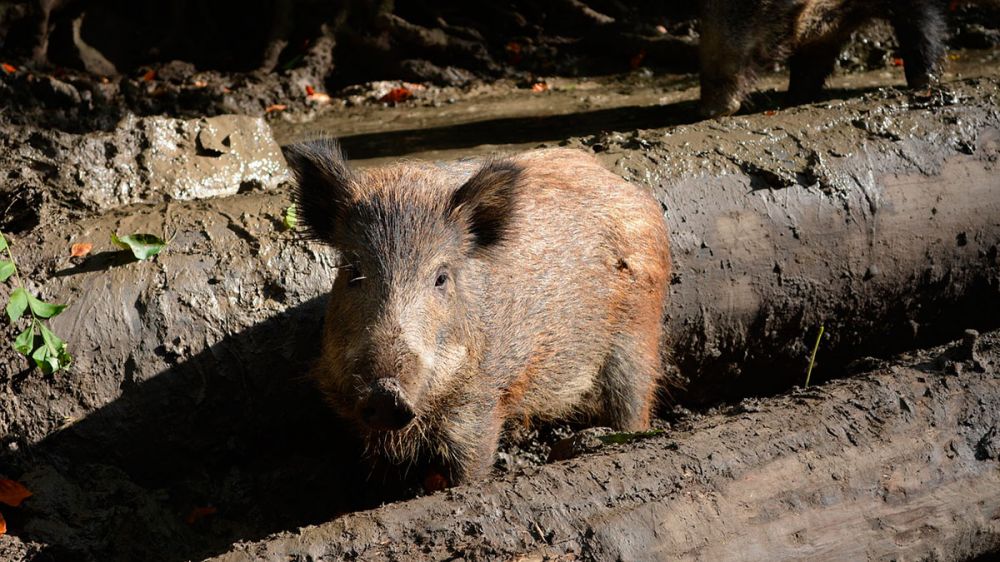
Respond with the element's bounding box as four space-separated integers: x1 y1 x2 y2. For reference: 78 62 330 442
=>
0 297 378 562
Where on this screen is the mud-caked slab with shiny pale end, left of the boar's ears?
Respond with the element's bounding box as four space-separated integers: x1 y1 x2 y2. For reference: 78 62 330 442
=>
0 115 288 232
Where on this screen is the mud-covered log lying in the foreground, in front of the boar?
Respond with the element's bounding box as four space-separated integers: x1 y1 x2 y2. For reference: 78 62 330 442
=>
216 333 1000 562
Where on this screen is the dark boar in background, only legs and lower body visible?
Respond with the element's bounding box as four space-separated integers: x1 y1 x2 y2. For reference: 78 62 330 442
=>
700 0 947 117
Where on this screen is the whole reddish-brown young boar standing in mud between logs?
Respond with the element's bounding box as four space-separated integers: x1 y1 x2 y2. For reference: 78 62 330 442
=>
286 141 670 484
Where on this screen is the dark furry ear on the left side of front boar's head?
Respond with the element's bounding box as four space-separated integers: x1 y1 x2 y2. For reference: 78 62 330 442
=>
282 139 354 242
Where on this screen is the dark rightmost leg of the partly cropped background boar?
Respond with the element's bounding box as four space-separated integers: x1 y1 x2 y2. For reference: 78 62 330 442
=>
891 0 945 88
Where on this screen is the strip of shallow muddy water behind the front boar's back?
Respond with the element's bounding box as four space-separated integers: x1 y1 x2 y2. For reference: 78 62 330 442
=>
271 51 1000 166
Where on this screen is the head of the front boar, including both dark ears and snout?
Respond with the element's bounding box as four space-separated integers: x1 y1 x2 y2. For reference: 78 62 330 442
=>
286 141 520 430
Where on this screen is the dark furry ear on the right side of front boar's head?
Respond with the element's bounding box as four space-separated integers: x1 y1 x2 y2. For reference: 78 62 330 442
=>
449 159 524 248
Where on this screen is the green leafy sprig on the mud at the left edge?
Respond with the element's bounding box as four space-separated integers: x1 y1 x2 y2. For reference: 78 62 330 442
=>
0 233 73 374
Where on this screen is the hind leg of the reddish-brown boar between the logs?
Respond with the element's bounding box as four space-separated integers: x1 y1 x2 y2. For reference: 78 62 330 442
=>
600 322 662 431
